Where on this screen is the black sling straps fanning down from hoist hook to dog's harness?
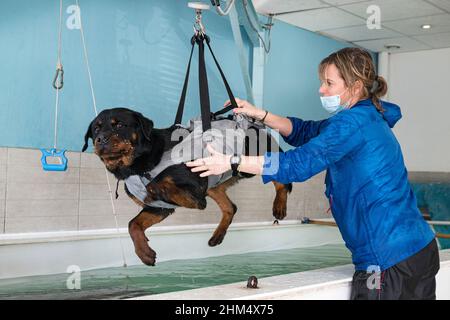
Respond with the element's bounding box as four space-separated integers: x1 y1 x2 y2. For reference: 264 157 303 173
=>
175 35 238 132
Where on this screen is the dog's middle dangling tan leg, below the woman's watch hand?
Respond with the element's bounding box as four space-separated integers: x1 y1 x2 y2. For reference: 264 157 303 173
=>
207 177 238 247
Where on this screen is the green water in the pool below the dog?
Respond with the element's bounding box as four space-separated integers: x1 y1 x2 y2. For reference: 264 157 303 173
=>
0 245 351 300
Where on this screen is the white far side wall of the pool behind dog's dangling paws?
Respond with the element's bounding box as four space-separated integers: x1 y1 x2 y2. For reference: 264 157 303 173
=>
0 220 343 279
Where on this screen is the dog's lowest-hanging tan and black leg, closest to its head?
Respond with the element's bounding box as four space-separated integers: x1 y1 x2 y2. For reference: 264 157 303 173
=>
128 207 174 266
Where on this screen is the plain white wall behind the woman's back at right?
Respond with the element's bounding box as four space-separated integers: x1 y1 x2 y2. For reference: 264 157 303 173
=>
388 49 450 172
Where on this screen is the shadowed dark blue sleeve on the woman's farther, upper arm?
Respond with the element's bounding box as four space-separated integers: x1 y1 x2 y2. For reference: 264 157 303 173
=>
282 117 327 147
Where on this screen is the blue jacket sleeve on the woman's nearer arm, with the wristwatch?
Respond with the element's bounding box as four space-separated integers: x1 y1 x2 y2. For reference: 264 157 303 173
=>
262 119 364 184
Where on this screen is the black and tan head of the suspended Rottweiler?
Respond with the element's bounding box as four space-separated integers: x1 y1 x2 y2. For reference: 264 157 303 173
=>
82 108 153 171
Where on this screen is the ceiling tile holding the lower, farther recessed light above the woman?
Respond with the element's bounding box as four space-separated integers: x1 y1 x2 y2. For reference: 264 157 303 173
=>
355 37 432 53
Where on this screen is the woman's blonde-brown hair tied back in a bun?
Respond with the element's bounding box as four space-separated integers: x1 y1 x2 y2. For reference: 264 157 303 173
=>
319 48 388 112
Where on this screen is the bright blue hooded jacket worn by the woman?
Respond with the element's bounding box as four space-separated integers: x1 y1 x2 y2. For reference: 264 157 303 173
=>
262 100 434 271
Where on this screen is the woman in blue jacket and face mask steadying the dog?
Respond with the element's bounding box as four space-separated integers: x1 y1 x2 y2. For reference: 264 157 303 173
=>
187 48 439 299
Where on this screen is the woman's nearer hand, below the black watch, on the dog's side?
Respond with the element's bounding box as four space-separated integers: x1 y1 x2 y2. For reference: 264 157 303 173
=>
186 144 231 177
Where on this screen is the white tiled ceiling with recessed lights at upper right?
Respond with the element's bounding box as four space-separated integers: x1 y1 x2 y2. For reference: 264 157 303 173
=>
253 0 450 53
